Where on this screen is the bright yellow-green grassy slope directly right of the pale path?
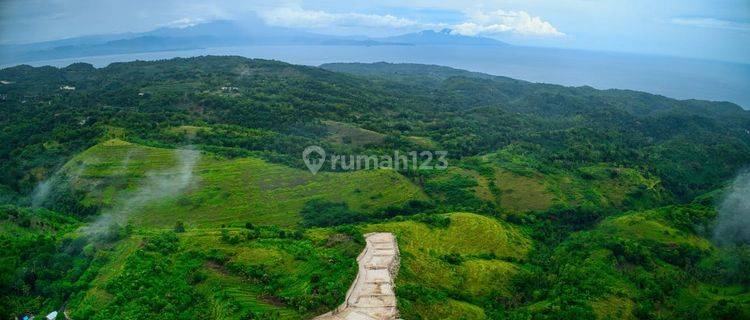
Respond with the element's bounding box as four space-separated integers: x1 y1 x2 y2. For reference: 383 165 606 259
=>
363 213 531 319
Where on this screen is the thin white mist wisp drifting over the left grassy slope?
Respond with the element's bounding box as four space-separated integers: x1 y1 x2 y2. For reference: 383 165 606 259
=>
82 149 201 238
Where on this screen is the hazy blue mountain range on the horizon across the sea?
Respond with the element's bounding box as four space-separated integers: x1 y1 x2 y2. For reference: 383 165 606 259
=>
0 17 507 64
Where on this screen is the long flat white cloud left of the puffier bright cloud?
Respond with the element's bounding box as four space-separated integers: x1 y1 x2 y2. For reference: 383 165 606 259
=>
259 7 420 28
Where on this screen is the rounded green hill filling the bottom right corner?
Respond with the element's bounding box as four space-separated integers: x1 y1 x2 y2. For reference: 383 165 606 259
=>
520 205 750 319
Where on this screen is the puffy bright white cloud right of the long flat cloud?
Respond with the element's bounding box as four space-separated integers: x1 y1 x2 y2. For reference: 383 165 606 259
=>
453 10 565 36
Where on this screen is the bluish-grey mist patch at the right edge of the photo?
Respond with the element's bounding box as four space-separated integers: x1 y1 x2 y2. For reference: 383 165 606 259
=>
713 170 750 245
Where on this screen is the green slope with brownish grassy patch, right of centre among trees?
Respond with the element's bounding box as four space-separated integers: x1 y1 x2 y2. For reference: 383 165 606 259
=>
423 152 665 214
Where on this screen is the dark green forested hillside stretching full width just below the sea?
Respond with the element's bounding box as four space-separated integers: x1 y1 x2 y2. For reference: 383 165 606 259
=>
0 57 750 201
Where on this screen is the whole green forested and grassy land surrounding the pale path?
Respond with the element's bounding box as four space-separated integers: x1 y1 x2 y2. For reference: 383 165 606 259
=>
0 56 750 319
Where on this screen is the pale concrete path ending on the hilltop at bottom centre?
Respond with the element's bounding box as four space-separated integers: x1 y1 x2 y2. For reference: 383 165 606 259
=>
315 232 399 320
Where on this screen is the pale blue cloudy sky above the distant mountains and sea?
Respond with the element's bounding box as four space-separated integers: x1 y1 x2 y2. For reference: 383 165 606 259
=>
0 0 750 63
